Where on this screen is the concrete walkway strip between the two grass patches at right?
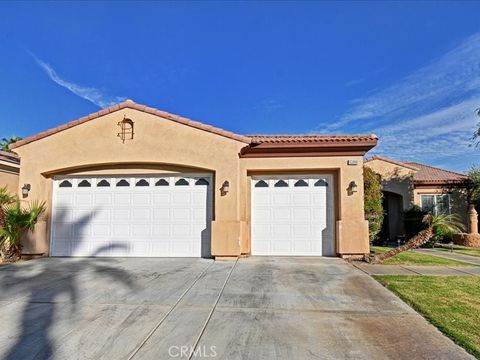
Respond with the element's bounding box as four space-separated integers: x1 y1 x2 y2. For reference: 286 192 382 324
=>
351 261 480 276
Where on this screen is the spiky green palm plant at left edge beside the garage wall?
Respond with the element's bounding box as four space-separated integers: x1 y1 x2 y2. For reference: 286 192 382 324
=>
0 199 45 258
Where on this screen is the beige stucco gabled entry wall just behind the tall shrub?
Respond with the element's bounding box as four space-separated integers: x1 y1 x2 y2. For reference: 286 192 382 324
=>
365 159 415 210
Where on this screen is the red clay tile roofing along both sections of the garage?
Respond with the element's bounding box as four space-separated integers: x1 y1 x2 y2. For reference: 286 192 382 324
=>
10 100 378 149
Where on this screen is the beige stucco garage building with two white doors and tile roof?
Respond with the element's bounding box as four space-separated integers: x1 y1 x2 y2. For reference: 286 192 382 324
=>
11 100 377 259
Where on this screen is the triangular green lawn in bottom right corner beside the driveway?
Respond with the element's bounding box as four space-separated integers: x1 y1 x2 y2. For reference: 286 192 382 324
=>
374 275 480 358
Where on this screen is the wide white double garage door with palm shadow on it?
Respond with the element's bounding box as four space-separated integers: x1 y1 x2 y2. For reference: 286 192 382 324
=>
50 175 212 257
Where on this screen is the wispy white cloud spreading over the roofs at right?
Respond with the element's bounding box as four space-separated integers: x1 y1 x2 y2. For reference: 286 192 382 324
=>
318 33 480 169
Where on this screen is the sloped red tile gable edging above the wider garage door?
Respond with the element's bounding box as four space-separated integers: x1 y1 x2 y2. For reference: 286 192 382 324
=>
10 100 250 149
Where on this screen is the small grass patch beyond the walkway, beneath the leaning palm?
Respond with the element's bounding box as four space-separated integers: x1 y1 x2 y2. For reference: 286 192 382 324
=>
371 246 475 266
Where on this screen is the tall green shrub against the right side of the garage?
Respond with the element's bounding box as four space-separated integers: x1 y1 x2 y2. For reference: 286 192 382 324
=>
363 166 384 243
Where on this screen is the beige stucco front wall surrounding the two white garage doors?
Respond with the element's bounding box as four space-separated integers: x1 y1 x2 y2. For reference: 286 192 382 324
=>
15 108 368 256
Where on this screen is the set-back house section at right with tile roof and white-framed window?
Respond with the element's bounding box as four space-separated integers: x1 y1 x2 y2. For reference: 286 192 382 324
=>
365 156 468 240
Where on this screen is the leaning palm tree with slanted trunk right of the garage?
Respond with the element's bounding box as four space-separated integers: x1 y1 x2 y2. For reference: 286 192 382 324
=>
366 214 464 264
